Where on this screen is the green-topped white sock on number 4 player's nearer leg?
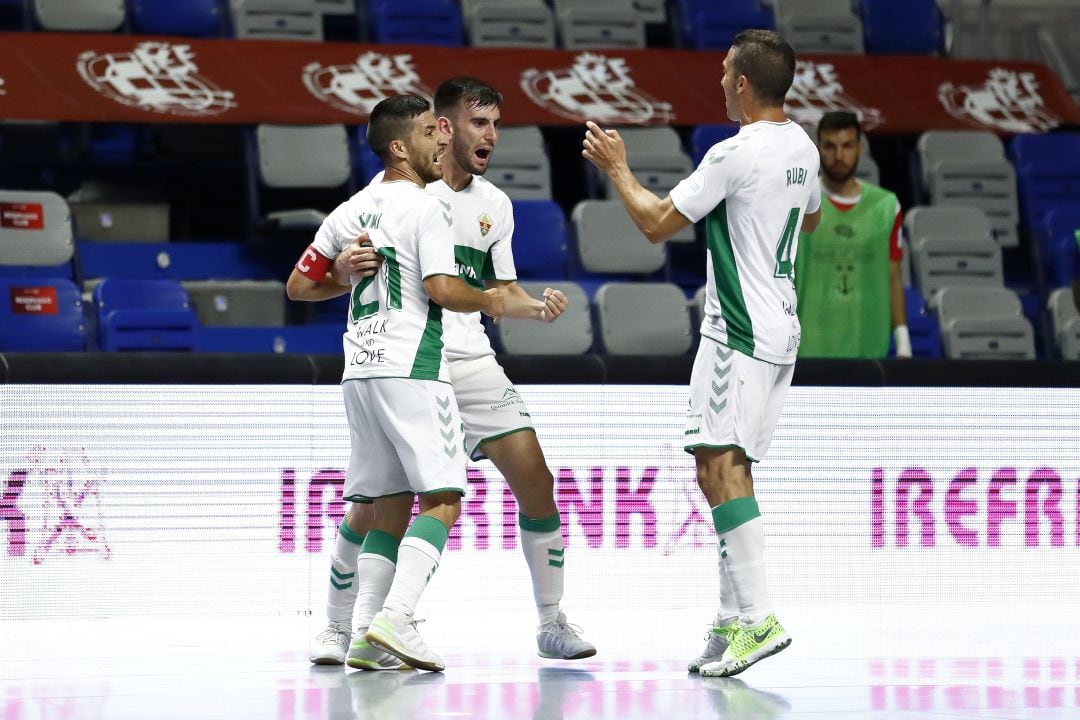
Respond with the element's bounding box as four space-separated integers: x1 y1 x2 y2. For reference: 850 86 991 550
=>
713 498 772 625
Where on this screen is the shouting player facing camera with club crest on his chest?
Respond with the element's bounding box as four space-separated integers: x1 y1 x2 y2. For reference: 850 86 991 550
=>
311 78 596 666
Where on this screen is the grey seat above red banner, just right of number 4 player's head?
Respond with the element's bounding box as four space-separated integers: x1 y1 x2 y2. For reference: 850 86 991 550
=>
772 0 863 53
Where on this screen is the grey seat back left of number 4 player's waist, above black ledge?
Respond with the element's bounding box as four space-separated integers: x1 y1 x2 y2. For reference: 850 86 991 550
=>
594 282 693 355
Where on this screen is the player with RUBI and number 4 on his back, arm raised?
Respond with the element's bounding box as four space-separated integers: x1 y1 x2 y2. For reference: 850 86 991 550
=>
582 30 821 676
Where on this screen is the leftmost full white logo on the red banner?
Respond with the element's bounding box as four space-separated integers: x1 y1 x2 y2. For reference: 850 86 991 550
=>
76 42 237 116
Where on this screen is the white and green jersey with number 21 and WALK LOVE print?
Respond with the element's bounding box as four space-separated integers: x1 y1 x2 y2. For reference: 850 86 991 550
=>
312 180 458 382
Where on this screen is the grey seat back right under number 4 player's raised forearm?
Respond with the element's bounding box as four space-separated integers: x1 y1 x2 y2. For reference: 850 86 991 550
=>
571 200 665 280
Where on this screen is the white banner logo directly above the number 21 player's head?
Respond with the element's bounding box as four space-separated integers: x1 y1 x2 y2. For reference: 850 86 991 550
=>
301 53 431 116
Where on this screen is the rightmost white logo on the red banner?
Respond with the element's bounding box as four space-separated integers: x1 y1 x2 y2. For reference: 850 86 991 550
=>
937 68 1061 133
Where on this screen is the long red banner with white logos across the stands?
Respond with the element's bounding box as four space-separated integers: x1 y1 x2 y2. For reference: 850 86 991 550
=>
0 32 1080 133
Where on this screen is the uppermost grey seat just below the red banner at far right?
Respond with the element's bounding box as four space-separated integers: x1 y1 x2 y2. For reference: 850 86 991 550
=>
917 131 1020 247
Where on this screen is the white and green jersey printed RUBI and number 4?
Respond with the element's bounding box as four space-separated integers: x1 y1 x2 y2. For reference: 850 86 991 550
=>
671 121 821 365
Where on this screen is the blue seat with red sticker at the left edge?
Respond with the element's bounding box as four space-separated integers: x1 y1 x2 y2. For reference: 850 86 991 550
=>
0 277 86 352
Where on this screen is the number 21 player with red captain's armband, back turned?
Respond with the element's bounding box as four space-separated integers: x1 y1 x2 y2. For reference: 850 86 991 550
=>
287 95 502 670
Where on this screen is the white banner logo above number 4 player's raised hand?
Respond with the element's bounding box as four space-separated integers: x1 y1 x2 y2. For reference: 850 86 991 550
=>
521 53 675 125
